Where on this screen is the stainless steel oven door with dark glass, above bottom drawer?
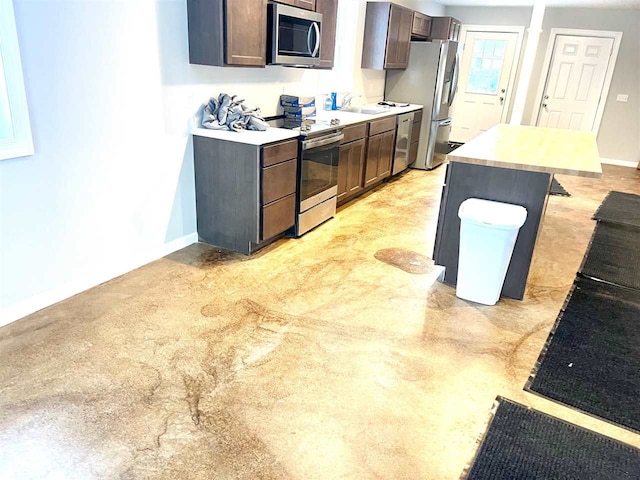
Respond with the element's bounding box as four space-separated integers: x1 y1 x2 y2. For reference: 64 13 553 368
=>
299 132 344 212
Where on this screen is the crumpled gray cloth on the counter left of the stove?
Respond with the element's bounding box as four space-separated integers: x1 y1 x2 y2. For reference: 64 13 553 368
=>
202 93 269 132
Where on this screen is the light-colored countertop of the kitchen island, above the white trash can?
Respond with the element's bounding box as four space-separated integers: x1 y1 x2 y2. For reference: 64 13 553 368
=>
447 124 602 178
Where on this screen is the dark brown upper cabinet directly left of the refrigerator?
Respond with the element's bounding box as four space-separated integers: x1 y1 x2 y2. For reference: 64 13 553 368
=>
361 2 413 70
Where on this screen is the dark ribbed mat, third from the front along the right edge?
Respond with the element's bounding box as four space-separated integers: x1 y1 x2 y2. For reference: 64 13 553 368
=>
579 222 640 289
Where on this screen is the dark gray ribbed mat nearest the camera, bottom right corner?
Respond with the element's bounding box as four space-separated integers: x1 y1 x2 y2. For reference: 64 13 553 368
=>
463 397 640 480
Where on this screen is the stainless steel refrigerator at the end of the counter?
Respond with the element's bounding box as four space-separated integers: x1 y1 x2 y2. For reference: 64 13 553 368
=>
384 40 459 170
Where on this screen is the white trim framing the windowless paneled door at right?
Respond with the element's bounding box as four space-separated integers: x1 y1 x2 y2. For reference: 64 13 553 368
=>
530 28 622 135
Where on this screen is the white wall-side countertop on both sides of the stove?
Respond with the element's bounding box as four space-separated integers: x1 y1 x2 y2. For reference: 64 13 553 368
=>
191 104 422 145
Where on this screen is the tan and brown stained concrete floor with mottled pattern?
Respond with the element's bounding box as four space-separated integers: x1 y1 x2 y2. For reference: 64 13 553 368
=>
0 166 640 480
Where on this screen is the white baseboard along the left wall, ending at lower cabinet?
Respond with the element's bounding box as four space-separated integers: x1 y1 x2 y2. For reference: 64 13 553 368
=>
0 233 198 327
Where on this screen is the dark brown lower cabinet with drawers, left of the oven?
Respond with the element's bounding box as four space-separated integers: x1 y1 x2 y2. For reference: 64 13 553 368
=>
193 136 298 254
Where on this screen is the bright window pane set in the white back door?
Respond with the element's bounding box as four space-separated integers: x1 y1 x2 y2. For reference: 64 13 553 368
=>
467 40 507 95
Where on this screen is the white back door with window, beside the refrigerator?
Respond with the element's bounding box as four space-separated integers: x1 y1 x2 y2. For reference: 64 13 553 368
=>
451 30 520 142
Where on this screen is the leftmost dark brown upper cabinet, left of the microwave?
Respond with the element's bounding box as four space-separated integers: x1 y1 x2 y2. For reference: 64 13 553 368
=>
187 0 267 67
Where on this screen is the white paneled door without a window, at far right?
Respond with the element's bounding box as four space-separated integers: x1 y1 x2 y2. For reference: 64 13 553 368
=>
536 35 613 131
